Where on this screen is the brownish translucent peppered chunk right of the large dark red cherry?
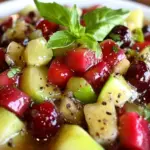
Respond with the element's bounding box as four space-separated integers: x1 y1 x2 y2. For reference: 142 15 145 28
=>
58 94 85 125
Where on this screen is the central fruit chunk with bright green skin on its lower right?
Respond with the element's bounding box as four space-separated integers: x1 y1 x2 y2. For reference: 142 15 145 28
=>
67 77 96 103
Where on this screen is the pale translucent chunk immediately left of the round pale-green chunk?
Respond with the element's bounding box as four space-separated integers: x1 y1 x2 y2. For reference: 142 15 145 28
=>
5 42 25 68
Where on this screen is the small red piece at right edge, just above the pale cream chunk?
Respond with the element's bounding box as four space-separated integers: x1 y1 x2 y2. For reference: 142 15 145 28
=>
132 41 150 52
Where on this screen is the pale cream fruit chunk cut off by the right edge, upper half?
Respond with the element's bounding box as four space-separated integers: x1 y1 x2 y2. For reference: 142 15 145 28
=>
139 46 150 68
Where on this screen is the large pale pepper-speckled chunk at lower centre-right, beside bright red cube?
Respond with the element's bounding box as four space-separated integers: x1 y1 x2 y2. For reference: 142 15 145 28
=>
84 100 118 145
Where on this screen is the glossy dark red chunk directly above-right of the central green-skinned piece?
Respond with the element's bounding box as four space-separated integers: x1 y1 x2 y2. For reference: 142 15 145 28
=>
84 61 110 92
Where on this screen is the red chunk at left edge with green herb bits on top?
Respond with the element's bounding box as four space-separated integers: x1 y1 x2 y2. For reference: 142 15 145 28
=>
0 69 19 86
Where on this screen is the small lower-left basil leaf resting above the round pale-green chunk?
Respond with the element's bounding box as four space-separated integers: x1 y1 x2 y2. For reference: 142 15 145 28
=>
47 30 75 49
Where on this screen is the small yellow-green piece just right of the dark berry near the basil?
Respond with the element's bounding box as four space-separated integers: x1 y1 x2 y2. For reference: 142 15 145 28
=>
132 28 144 42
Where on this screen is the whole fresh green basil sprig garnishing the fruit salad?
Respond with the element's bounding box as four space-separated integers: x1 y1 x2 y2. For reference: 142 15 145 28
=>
34 0 129 57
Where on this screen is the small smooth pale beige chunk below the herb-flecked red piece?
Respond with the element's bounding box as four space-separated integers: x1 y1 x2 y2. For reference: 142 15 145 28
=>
113 58 130 75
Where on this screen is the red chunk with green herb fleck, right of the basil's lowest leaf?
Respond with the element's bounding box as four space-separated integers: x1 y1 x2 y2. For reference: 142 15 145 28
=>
100 39 126 68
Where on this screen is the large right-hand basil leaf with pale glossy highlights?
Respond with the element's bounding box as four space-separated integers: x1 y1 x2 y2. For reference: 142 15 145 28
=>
84 7 129 41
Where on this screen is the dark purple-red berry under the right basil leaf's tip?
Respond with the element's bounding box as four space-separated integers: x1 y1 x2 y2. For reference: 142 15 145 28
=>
107 25 131 48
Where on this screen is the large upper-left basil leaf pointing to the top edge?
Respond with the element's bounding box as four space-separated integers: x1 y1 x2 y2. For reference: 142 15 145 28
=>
34 0 71 27
